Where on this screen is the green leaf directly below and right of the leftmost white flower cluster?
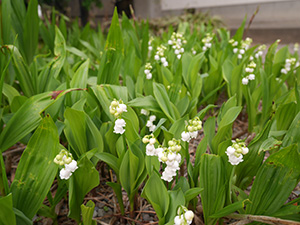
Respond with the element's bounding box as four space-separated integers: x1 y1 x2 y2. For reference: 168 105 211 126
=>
68 157 100 222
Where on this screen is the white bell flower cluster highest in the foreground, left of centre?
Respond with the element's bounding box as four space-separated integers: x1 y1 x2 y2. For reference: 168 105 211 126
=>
109 99 127 134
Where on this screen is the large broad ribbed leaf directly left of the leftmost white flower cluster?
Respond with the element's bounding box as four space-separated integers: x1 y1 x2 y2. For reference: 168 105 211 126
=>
11 116 60 219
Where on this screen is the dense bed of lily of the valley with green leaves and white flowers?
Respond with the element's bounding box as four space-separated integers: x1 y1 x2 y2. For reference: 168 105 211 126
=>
0 0 300 225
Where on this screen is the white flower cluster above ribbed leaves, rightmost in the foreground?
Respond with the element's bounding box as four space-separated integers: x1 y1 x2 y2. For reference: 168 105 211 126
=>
225 139 249 165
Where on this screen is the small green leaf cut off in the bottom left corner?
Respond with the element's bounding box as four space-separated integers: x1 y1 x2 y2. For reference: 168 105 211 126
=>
0 193 16 225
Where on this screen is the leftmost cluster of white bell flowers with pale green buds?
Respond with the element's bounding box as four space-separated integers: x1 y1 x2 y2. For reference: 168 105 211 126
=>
53 149 78 180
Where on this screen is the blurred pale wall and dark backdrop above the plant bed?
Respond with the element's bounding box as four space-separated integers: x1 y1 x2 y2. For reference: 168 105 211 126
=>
27 0 300 43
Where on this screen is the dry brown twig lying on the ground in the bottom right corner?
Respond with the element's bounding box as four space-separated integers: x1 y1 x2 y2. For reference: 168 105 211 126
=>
226 213 300 225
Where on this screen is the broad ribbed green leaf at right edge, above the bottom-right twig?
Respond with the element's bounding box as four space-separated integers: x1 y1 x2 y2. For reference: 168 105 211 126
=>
246 145 300 215
